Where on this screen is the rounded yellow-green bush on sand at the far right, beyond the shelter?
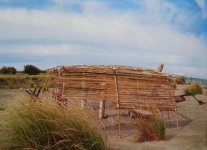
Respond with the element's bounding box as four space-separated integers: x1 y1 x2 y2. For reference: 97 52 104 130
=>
185 82 203 95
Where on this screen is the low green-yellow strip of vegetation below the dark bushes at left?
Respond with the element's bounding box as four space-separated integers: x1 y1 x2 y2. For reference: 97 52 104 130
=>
0 74 47 89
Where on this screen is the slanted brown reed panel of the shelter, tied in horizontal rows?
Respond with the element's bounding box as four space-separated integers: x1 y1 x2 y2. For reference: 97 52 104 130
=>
49 65 176 111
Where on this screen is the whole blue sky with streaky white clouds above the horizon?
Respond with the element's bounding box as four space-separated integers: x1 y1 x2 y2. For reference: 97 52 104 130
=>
0 0 207 79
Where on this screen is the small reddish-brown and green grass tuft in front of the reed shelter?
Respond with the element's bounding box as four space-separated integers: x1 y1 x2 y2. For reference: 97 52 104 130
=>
135 118 165 142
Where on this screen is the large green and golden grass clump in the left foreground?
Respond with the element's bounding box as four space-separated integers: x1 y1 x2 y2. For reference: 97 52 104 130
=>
1 96 106 150
